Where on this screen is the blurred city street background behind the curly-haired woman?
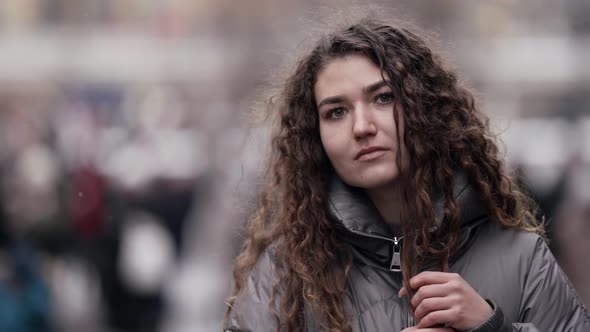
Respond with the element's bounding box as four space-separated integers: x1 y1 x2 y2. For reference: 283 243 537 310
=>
0 0 590 332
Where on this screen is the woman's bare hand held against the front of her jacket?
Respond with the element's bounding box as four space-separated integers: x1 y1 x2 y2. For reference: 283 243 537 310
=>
399 271 493 331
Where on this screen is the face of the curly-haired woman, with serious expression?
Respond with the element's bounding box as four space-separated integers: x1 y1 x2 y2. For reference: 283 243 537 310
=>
314 55 406 189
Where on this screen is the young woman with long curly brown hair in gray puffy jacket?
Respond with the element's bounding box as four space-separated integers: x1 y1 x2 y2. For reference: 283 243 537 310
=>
225 20 590 331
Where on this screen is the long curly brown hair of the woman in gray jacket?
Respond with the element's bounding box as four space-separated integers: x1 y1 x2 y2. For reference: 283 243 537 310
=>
226 19 542 331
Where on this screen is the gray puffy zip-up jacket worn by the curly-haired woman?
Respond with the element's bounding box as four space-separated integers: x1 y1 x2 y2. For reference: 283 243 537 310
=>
224 175 590 332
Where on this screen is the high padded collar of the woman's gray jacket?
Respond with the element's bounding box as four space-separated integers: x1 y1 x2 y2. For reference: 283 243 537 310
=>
328 172 488 266
